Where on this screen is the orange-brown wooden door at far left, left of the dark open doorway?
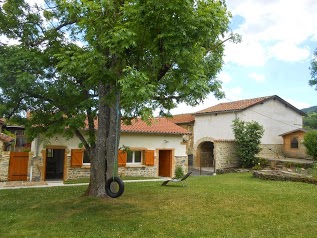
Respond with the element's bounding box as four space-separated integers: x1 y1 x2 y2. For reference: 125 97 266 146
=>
9 152 29 181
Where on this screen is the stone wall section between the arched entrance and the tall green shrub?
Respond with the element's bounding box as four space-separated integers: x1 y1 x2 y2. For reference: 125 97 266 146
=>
214 140 239 170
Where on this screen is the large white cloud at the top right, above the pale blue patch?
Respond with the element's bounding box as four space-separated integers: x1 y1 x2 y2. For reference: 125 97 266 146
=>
225 0 317 66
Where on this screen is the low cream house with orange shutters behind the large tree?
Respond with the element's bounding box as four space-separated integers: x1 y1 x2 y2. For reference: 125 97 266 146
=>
24 118 189 181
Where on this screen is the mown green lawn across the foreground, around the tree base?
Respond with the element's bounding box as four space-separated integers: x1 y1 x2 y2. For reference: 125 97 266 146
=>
0 173 317 238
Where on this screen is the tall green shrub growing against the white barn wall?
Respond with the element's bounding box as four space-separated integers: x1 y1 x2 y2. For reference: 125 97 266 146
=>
232 119 264 168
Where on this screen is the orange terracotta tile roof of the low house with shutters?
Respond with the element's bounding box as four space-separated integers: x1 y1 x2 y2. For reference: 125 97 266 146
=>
121 117 190 135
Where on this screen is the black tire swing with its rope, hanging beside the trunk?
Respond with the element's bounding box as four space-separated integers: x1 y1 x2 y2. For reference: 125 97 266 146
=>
105 88 124 198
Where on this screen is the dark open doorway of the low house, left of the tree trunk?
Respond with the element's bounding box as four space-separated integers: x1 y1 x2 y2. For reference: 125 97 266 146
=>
45 149 65 180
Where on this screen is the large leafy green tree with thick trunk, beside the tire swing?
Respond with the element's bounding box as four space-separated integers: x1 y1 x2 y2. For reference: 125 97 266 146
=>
0 0 240 196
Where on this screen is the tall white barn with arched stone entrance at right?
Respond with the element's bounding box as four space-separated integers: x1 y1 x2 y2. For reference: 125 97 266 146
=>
175 95 307 171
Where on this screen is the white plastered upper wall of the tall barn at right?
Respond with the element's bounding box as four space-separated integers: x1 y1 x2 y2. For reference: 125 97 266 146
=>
194 99 302 144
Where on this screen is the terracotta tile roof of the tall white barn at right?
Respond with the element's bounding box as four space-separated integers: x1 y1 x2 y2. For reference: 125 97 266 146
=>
195 95 306 116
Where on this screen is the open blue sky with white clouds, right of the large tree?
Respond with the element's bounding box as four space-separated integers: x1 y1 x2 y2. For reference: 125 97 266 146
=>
172 0 317 114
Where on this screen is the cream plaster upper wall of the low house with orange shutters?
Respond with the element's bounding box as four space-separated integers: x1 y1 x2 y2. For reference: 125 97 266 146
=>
31 133 186 156
